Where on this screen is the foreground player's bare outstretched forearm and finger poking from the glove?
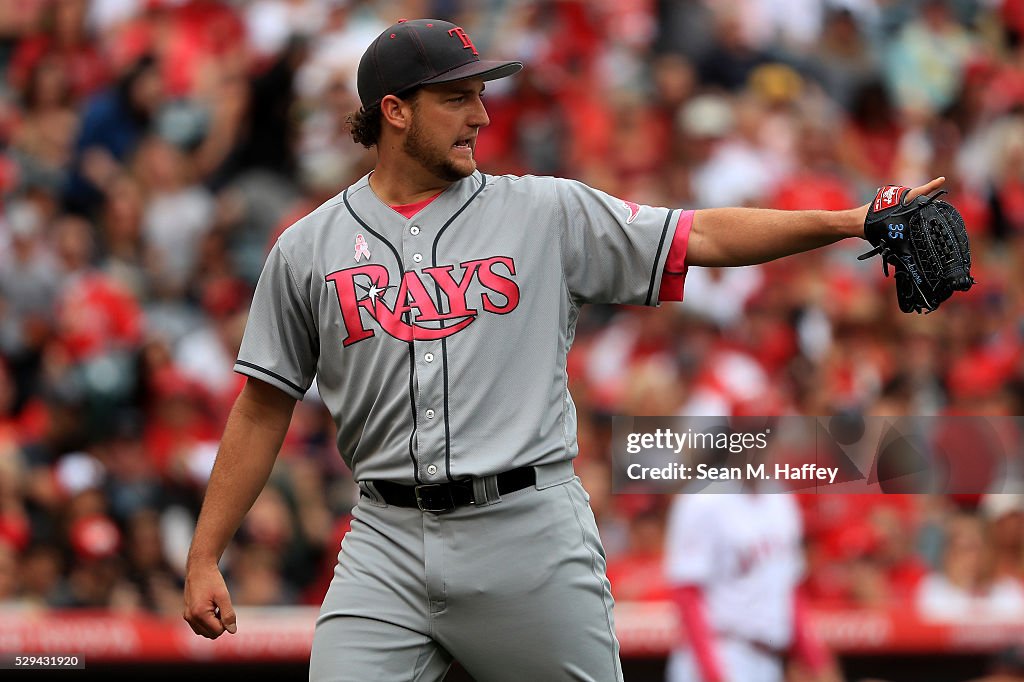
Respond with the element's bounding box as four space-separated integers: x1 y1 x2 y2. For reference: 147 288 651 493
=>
686 177 945 267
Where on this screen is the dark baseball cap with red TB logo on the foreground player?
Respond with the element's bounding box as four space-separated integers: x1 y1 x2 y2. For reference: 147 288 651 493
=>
356 19 522 111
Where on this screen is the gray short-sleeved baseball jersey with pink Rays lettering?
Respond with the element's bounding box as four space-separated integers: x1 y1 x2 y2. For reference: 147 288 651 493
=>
234 172 689 484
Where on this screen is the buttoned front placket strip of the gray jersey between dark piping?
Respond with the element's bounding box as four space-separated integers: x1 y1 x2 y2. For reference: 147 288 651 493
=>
396 212 447 483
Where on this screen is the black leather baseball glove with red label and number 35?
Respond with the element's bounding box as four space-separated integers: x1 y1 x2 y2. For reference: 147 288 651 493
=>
859 185 974 312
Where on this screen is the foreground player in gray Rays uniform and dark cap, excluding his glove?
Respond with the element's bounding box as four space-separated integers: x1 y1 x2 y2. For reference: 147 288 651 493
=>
184 19 940 682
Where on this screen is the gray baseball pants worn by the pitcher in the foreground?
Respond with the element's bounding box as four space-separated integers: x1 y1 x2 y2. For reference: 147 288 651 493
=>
309 462 623 682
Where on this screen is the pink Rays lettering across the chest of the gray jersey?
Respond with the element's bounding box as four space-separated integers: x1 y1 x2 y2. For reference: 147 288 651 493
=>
325 256 519 346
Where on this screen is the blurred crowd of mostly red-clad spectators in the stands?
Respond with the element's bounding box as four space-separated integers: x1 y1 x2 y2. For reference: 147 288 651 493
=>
0 0 1024 619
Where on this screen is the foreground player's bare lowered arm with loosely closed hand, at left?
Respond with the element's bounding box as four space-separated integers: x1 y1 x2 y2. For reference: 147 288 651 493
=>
184 379 295 639
